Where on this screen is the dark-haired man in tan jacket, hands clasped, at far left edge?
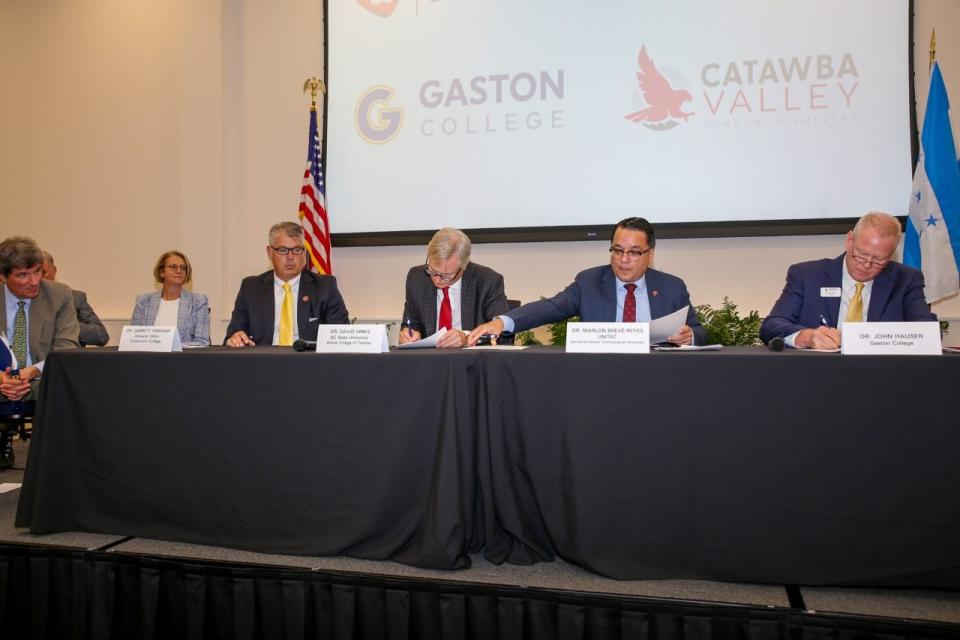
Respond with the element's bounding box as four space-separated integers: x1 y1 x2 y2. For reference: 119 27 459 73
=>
0 237 80 468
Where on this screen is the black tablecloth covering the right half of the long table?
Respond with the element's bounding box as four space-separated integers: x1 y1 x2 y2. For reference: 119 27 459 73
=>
480 349 960 587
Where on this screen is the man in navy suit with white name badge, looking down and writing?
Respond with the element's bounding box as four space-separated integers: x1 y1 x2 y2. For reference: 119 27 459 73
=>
760 212 937 349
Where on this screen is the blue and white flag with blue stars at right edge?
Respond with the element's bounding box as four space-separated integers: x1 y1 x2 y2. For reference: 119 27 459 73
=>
903 63 960 303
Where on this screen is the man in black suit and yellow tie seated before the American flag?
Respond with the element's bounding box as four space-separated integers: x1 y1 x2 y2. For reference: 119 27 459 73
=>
223 222 350 347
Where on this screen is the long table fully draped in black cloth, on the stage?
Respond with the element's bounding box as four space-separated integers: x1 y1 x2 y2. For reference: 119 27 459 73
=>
17 347 960 588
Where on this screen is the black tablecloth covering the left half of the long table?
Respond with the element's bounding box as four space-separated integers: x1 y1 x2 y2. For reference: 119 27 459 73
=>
17 347 479 568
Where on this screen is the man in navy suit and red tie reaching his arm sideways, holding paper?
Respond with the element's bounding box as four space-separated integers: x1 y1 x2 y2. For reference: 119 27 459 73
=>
468 218 706 344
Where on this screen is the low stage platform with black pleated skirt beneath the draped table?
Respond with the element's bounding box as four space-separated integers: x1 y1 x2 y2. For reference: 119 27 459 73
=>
0 441 960 640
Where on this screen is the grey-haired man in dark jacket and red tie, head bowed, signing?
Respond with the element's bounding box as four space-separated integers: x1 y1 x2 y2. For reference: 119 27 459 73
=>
400 227 507 347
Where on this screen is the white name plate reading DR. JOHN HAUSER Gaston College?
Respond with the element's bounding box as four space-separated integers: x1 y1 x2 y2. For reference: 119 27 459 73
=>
840 322 943 356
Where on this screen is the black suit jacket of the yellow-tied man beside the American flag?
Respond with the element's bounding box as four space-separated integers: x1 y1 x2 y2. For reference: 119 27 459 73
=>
224 270 350 344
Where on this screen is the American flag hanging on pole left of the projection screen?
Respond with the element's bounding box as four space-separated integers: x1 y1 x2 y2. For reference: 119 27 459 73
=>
300 107 333 274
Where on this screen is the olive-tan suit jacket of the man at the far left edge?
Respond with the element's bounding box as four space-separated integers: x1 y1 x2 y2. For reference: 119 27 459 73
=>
0 280 80 367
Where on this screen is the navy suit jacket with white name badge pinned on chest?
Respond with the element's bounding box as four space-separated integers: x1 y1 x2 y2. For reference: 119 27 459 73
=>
760 254 937 342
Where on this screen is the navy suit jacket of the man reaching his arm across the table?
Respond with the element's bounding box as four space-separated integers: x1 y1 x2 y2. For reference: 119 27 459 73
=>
507 265 707 344
